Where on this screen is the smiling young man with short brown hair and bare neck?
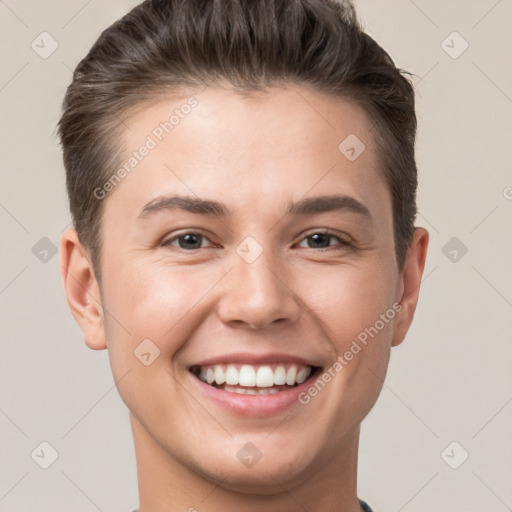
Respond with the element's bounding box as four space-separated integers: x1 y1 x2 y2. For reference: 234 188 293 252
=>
59 0 428 512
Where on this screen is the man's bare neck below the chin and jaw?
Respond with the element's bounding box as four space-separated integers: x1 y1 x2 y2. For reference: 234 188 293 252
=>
130 413 361 512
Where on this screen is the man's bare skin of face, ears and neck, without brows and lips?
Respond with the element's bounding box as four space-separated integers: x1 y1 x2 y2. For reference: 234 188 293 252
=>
60 85 428 512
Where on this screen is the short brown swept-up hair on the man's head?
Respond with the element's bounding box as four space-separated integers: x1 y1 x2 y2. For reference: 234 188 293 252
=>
58 0 417 280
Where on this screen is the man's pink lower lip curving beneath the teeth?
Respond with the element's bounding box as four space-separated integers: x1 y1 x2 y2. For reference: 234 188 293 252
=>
188 368 319 416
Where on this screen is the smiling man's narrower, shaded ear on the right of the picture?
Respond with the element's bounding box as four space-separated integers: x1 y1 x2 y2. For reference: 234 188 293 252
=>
391 228 429 346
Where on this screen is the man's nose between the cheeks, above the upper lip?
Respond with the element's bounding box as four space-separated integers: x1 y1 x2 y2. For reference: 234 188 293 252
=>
218 247 300 329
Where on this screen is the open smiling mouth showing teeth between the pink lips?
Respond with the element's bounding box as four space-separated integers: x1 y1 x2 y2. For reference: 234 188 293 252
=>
190 363 321 395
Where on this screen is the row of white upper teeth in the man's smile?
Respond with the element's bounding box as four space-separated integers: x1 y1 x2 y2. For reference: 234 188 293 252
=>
199 364 311 387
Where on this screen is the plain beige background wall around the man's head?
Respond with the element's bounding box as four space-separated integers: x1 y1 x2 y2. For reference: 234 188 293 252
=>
0 0 512 512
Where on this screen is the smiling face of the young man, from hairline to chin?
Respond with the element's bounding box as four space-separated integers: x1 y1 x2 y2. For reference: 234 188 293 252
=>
60 83 426 489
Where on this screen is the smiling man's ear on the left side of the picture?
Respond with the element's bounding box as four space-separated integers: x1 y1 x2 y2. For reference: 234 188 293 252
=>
60 228 107 350
